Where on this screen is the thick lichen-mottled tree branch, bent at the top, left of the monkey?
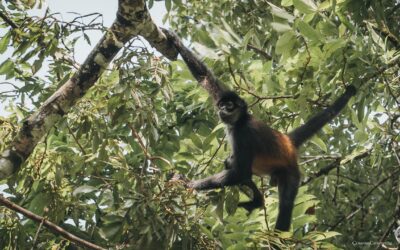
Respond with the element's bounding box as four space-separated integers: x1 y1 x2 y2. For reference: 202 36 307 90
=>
0 0 177 180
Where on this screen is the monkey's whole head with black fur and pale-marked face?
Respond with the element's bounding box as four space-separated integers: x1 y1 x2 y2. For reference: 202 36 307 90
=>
217 91 248 125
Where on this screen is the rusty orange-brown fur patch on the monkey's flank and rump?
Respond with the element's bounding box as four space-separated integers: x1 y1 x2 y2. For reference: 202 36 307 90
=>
251 132 297 176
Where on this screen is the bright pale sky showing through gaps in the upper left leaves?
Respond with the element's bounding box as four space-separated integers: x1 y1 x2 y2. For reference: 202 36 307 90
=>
0 0 166 116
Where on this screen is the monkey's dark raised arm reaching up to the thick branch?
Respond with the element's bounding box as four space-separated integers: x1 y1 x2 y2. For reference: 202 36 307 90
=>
162 29 224 101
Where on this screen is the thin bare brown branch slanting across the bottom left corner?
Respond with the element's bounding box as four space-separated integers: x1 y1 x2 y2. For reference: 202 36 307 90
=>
0 195 105 250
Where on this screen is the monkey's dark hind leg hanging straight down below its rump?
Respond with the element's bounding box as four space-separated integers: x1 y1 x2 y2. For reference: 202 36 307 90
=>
275 168 300 231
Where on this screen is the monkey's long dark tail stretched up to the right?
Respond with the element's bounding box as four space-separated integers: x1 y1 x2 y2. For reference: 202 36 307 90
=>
289 85 356 148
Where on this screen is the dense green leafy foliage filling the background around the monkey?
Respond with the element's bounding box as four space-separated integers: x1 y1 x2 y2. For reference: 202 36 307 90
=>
0 0 400 249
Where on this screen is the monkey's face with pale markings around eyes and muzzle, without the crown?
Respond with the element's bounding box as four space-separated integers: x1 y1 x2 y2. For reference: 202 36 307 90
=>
218 99 245 125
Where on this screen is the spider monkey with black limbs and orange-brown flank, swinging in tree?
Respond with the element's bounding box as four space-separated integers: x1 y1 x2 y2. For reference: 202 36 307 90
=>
164 30 356 231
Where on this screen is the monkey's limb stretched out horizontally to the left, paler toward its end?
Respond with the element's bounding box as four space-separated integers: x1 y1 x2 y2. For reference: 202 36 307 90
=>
188 168 247 190
